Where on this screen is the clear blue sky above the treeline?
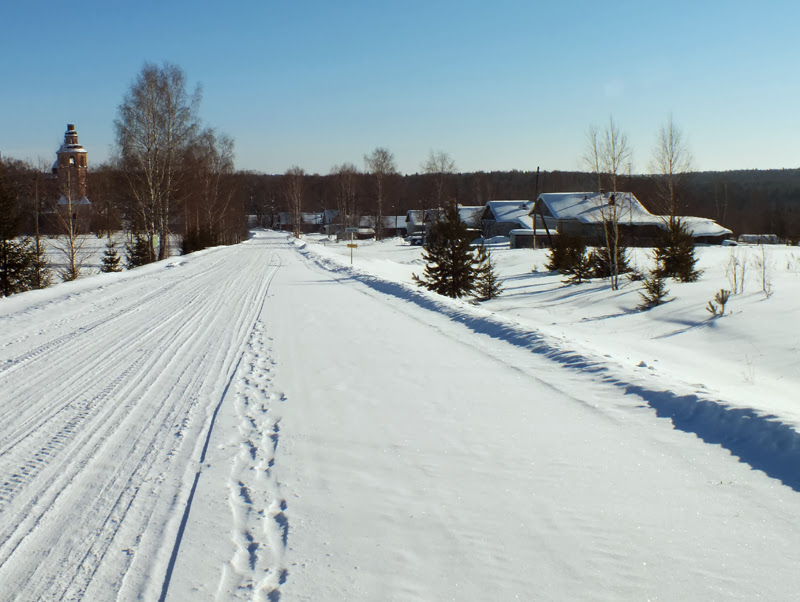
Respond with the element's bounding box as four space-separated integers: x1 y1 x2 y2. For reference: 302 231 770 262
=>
0 0 800 173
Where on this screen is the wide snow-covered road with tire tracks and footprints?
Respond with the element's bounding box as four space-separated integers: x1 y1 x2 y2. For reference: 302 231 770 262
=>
0 227 800 602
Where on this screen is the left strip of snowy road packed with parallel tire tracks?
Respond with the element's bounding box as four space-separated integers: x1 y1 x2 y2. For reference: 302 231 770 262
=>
0 240 284 599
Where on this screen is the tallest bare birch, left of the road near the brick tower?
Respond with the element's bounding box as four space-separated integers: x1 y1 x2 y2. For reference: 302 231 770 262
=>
114 63 201 259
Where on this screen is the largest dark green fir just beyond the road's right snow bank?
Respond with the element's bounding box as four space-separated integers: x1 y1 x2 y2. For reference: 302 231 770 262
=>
413 206 475 298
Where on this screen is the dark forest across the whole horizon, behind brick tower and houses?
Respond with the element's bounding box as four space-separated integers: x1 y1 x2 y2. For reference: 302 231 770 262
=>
5 159 800 242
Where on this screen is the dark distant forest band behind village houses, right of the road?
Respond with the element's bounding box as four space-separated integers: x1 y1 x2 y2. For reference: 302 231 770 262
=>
235 169 800 241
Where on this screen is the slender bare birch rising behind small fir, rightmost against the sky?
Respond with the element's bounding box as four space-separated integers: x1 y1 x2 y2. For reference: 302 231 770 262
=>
650 115 693 218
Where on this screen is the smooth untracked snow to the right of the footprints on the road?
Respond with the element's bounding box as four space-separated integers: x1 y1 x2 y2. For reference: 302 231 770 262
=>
268 236 798 600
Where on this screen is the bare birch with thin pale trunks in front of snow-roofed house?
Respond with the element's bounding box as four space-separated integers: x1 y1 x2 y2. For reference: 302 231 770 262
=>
584 117 632 290
